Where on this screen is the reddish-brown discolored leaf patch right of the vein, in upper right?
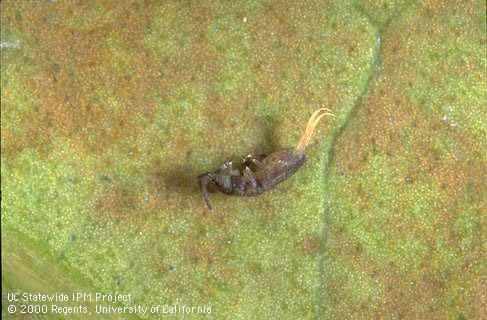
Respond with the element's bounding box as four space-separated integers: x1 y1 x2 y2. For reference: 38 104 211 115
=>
337 2 479 182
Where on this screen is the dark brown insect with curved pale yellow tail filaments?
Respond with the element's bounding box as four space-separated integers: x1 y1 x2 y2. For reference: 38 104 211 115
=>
198 108 333 210
